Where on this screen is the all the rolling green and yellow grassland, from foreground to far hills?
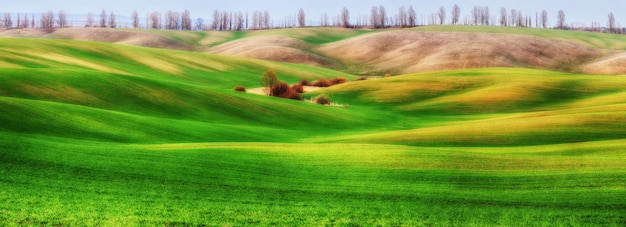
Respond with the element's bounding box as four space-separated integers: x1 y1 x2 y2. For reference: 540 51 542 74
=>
0 27 626 226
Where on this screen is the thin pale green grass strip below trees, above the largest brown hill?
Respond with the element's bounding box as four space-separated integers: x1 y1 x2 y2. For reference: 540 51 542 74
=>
413 26 626 50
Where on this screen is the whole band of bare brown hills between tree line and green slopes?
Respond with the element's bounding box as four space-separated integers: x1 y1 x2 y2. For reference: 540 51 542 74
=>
0 26 626 75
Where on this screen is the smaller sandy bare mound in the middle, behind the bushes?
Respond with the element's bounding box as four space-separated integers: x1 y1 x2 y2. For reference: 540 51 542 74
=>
208 36 332 66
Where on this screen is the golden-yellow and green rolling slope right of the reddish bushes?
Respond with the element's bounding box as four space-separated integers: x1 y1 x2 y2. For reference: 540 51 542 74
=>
310 68 626 146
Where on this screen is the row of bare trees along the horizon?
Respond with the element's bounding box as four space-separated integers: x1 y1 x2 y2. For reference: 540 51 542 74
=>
0 4 625 33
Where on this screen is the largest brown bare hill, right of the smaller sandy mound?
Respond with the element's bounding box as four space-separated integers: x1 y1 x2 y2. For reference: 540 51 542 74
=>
318 31 602 73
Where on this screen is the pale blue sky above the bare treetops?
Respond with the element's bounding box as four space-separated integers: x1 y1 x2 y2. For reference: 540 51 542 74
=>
0 0 626 25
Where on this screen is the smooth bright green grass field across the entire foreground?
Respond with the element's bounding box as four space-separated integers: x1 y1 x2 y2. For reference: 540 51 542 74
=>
0 133 626 226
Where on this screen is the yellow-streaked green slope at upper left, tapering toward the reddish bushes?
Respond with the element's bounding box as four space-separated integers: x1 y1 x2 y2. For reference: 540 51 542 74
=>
0 38 351 88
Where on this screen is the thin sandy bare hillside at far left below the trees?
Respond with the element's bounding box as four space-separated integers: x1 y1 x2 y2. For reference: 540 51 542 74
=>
0 28 194 50
